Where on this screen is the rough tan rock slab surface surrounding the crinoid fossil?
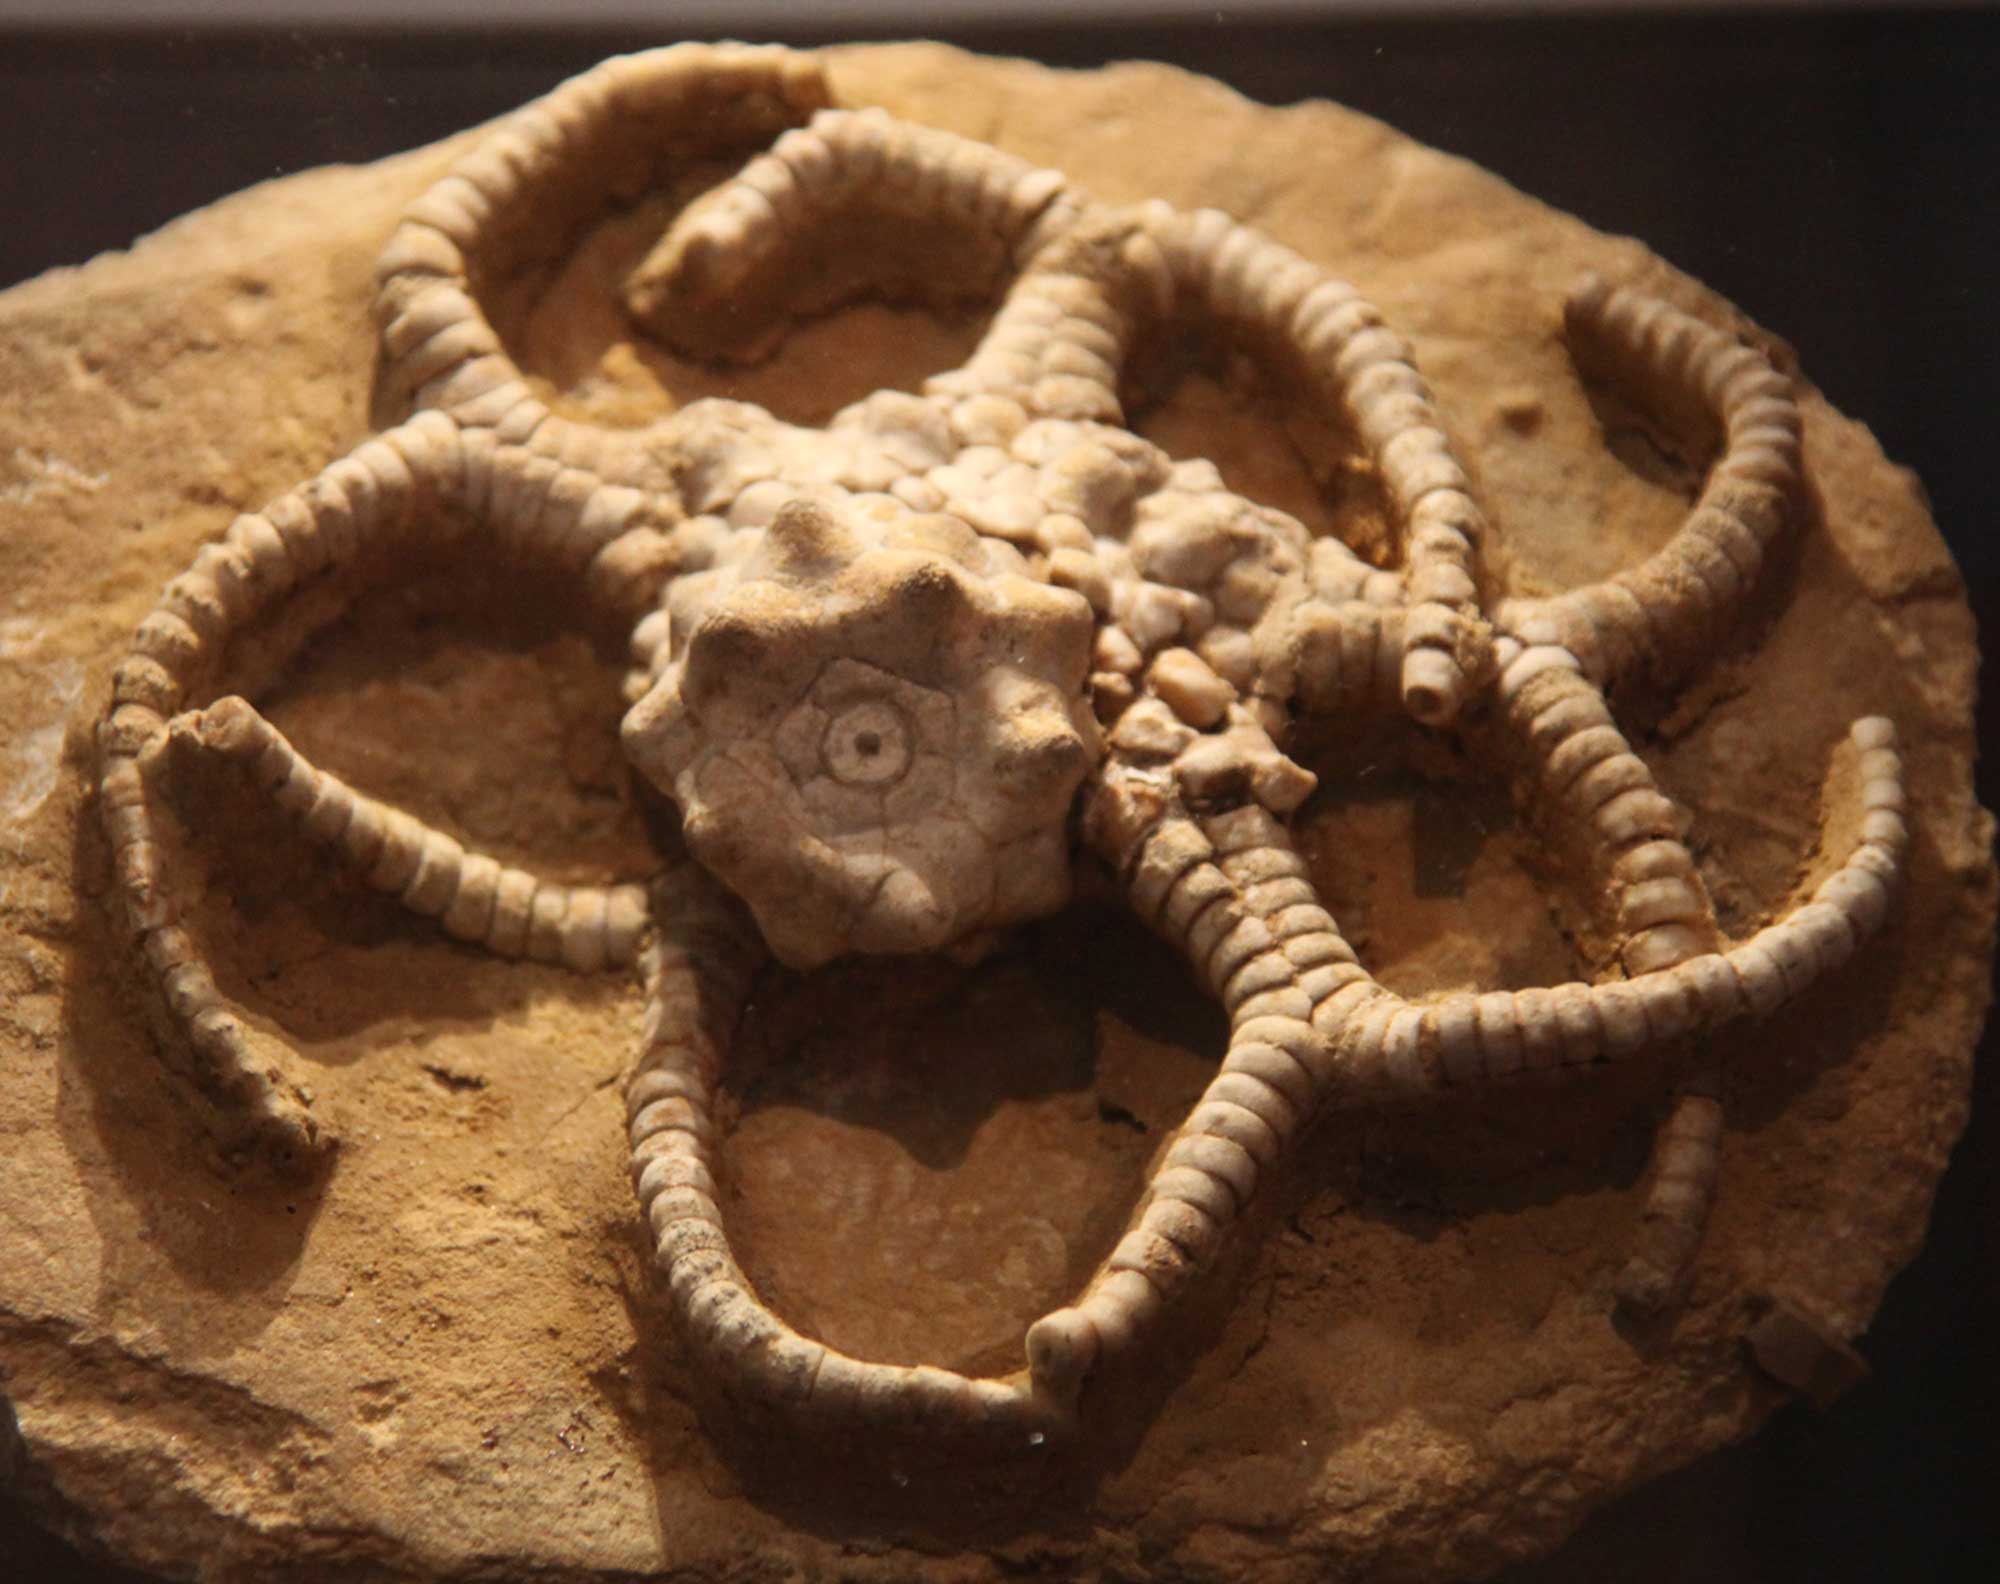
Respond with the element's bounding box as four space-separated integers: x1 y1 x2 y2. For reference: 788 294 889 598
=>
0 46 1994 1580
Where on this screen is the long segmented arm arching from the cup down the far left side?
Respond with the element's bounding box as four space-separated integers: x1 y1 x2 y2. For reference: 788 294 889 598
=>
98 412 664 1160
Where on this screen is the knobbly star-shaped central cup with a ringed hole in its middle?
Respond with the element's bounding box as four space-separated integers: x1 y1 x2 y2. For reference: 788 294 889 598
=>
624 490 1098 966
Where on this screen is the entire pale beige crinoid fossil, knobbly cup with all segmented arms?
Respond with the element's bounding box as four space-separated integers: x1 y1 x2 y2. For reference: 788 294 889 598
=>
100 46 1908 1444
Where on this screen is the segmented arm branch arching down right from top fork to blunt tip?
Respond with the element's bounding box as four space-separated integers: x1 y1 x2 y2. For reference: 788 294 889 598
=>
1142 202 1486 726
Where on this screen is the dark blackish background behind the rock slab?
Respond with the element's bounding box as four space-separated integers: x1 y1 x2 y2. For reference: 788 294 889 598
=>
0 6 2000 1584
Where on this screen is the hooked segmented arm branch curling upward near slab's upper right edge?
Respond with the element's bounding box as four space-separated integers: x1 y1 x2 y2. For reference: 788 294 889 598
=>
1494 276 1802 684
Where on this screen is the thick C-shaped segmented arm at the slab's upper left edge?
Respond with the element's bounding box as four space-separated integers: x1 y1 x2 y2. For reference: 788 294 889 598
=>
376 44 826 486
